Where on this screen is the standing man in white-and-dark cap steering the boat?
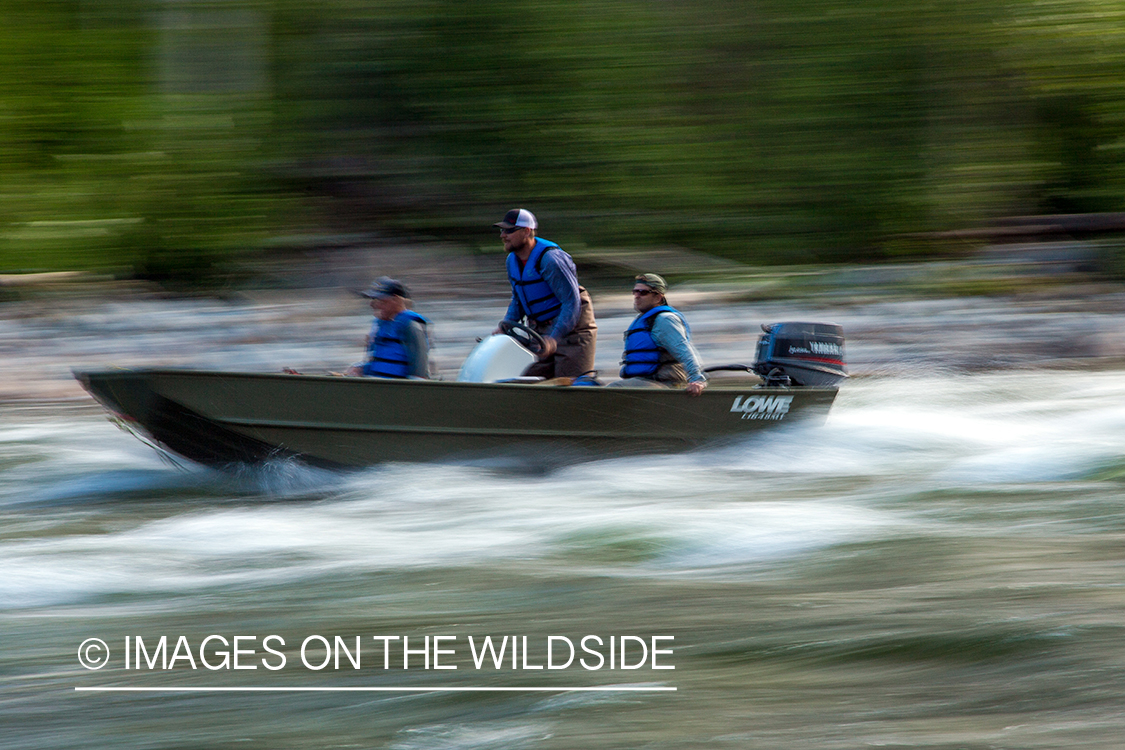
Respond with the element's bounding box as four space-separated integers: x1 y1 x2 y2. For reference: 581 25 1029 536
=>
493 208 597 379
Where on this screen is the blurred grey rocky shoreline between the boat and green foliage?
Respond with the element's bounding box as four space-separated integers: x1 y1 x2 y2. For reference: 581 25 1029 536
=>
0 252 1125 403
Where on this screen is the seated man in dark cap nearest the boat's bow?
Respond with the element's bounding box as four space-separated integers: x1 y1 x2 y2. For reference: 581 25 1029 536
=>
344 277 430 379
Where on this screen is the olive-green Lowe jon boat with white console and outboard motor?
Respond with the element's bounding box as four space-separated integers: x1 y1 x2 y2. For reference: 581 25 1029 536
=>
74 323 847 468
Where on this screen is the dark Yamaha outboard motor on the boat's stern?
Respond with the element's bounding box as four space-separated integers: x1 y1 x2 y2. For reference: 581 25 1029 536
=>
750 323 847 386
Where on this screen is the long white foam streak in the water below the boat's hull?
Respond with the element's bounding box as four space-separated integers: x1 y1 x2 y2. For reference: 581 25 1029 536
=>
0 468 893 606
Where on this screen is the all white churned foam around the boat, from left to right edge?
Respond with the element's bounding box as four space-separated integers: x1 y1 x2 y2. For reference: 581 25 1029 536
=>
0 372 1125 607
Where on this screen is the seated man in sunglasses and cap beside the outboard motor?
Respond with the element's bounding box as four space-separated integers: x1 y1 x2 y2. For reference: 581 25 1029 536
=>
611 273 707 396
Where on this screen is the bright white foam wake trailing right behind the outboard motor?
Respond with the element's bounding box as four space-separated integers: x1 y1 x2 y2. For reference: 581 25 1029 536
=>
746 372 1125 487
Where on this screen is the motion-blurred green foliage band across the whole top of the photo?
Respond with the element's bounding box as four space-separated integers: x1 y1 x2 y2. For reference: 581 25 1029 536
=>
0 0 1125 281
